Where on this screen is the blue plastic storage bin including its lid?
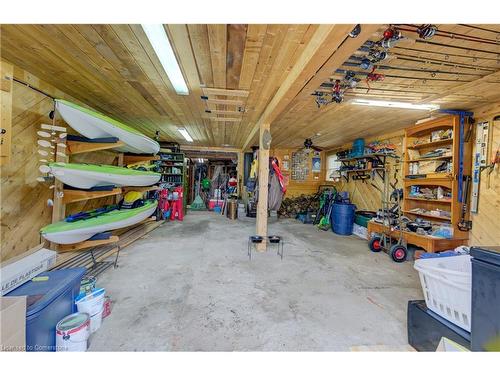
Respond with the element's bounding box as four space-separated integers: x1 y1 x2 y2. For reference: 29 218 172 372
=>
8 268 86 351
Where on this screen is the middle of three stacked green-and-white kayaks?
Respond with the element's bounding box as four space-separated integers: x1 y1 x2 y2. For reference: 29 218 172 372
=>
48 163 161 189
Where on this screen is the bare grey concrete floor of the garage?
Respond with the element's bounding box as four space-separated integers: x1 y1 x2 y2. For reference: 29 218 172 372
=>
89 212 422 351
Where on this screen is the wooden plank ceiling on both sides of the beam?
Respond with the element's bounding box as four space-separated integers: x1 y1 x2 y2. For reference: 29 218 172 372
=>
0 24 500 148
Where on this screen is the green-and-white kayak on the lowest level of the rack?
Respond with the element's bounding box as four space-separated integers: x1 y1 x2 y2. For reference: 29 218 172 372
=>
40 201 158 245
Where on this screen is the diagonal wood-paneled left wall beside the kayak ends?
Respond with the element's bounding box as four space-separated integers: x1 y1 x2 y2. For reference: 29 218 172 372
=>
0 84 56 261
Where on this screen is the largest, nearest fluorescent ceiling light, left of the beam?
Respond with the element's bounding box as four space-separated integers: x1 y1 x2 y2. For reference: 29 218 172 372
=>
141 24 189 95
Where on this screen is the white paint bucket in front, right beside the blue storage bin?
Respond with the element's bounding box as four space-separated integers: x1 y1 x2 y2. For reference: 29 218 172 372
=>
56 313 90 352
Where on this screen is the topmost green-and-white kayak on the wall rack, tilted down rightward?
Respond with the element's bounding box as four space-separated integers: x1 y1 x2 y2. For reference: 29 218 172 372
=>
56 99 160 154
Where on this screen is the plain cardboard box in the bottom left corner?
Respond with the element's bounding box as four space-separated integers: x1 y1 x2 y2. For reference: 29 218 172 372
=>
0 296 26 352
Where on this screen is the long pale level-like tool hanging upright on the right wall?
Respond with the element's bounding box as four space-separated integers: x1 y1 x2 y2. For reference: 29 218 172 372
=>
470 121 489 213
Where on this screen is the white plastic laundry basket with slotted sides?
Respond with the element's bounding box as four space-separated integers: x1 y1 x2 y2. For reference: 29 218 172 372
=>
414 255 472 332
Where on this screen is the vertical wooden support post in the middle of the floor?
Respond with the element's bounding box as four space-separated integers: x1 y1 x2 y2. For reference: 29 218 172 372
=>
256 123 271 251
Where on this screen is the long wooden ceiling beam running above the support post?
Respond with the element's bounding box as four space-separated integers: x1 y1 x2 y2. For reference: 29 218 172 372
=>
243 24 381 149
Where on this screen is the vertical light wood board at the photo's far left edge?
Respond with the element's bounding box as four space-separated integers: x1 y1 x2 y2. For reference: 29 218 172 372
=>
0 61 14 166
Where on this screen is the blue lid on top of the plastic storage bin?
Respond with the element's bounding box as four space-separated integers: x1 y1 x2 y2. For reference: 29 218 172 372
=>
6 267 87 317
